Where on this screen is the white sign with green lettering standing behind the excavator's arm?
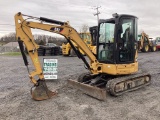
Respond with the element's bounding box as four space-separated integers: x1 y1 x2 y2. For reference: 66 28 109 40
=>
43 58 58 79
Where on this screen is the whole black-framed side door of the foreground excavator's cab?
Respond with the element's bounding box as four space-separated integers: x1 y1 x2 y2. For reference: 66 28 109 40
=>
115 17 137 64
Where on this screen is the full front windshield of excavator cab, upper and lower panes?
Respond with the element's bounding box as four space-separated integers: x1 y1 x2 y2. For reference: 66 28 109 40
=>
98 21 115 62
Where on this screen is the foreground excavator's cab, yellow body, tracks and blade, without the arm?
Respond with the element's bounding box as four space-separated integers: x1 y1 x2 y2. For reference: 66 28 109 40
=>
70 14 151 100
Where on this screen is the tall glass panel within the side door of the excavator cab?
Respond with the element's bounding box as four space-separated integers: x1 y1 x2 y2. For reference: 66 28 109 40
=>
118 18 136 62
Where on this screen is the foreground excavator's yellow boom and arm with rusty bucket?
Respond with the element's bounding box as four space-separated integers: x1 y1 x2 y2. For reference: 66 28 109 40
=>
15 13 98 100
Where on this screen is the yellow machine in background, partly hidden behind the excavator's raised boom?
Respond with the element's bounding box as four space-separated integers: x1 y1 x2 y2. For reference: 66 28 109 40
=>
62 32 91 56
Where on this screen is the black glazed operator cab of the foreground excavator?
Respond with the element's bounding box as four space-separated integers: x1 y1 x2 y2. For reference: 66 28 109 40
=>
97 15 137 64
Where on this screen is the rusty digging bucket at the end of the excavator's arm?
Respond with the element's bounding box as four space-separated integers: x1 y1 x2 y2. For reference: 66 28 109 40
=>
31 80 57 101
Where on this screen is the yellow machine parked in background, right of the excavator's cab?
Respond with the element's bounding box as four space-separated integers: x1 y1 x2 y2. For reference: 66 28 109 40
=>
138 31 157 52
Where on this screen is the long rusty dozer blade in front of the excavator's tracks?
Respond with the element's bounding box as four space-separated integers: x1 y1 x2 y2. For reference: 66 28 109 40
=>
68 79 107 101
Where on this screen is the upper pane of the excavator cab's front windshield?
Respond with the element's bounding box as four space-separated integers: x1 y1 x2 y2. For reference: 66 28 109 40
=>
99 23 115 43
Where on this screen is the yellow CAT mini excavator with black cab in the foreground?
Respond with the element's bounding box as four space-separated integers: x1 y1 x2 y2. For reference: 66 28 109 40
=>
15 12 151 100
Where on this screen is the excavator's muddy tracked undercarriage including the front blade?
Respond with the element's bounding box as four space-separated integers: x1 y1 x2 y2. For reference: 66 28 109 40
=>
68 73 151 100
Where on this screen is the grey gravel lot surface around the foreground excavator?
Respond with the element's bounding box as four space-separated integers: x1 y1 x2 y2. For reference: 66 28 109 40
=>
0 52 160 120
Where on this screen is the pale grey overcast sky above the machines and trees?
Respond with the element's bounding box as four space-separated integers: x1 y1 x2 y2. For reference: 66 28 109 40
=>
0 0 160 38
